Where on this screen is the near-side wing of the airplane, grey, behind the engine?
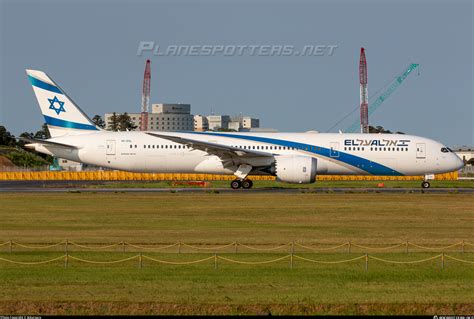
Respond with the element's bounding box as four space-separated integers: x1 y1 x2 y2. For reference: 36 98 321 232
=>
146 132 273 167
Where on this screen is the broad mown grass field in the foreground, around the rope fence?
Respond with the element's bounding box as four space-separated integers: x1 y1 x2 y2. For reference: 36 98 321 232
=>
0 192 474 314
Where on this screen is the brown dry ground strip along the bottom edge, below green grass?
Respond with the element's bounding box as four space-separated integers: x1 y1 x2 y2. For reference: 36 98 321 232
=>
0 301 474 315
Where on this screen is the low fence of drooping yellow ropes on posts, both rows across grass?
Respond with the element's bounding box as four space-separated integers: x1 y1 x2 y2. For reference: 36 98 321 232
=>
0 240 474 271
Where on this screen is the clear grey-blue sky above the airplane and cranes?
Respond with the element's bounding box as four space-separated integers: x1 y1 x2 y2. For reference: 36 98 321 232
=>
0 0 474 146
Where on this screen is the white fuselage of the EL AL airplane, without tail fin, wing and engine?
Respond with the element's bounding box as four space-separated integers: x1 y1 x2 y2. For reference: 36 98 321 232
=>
36 131 463 179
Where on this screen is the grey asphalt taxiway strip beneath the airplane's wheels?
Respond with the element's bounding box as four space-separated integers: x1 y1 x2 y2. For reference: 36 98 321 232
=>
0 181 474 194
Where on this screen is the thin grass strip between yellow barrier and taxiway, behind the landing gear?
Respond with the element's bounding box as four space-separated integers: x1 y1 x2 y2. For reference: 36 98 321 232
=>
93 180 474 189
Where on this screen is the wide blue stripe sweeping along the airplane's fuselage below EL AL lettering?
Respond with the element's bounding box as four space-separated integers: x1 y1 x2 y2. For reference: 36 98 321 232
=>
190 132 403 176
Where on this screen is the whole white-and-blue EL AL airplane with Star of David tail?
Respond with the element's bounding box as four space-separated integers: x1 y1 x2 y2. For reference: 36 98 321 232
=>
25 70 464 189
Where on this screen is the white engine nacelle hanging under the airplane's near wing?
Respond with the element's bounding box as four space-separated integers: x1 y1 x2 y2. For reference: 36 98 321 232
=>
275 155 318 184
